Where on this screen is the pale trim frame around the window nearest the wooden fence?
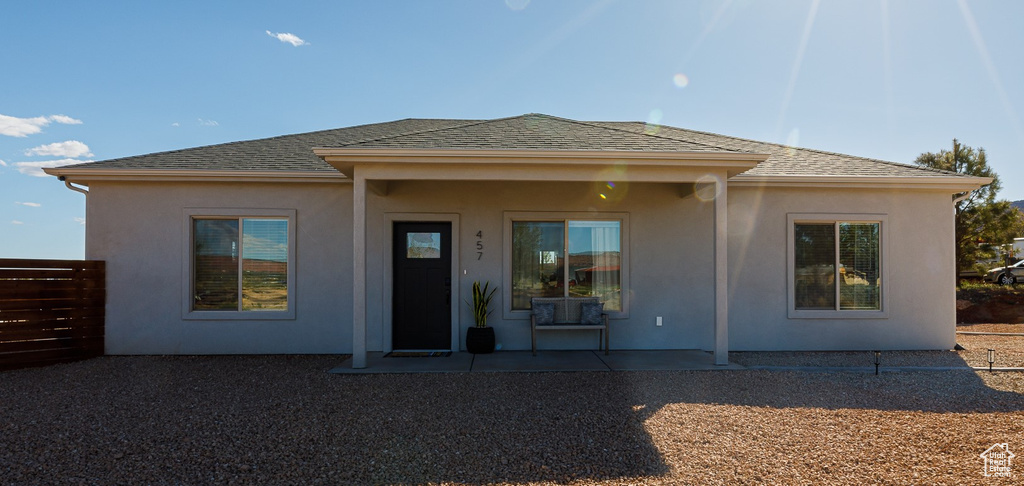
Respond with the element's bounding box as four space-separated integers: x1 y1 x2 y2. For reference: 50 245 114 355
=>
181 208 297 320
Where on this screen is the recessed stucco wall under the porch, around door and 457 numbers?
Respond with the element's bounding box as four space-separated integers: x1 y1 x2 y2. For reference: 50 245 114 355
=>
367 181 715 351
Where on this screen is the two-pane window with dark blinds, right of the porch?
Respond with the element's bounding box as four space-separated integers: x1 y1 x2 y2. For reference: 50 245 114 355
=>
790 215 884 317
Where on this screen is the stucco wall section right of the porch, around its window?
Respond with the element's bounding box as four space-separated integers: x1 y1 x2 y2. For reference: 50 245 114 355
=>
729 186 955 351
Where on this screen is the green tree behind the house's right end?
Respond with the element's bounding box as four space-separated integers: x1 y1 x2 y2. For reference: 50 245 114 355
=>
914 138 1024 281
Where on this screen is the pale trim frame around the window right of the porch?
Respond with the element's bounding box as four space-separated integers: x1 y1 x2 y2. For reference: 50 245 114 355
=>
785 213 889 319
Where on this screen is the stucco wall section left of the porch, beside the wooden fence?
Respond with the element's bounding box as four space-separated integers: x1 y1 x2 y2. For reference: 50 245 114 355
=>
86 182 352 354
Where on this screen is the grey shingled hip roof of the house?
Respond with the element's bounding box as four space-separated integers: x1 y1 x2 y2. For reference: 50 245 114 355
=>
56 114 955 177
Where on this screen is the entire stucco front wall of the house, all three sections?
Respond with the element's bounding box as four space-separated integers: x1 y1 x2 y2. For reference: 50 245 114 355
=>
86 177 955 354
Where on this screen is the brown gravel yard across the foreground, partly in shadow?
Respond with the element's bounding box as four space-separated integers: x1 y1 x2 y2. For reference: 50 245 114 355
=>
0 356 1024 484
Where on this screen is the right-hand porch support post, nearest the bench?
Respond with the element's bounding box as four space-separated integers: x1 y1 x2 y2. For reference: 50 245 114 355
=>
715 179 729 366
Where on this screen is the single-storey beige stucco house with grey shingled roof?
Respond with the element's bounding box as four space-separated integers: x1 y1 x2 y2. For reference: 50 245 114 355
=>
46 115 990 367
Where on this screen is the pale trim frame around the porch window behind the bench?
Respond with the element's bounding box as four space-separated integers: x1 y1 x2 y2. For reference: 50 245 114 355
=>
502 211 631 319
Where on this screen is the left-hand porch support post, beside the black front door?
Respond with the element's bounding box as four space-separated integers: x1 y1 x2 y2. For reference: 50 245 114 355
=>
352 172 367 368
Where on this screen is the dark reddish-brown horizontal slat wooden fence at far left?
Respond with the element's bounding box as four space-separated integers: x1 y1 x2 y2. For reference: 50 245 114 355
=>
0 259 106 369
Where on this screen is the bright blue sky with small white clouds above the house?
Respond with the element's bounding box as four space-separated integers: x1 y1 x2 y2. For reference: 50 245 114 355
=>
0 0 1024 258
